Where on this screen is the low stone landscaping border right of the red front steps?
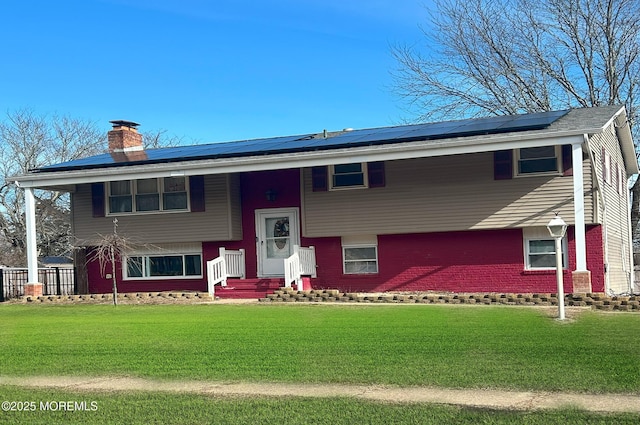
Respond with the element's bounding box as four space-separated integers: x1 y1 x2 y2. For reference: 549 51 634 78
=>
260 288 640 312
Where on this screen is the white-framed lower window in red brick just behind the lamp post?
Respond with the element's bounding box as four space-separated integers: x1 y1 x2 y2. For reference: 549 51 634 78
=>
522 227 568 270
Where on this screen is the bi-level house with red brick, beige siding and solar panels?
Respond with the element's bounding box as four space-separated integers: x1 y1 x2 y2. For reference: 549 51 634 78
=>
13 107 638 294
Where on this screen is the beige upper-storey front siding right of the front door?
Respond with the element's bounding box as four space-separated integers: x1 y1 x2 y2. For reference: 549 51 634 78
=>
303 152 593 237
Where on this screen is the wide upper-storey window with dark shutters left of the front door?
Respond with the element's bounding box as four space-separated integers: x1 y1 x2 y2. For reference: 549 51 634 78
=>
107 177 189 214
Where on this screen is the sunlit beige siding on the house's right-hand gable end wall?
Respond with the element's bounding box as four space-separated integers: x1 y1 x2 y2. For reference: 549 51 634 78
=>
589 126 632 294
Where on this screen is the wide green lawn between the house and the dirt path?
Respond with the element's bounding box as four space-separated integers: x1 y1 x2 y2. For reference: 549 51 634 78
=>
0 304 640 393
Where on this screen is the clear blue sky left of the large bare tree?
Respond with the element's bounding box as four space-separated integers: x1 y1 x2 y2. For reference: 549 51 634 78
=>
0 0 427 143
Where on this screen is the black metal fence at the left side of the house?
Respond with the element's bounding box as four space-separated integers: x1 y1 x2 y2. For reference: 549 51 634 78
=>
0 267 78 302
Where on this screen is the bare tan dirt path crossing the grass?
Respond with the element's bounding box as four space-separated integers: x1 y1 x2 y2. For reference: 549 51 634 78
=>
0 376 640 413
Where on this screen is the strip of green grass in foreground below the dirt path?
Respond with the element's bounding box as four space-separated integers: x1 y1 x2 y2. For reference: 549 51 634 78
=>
0 386 639 425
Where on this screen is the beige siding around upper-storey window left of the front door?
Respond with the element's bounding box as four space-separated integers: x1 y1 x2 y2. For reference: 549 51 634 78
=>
73 175 242 245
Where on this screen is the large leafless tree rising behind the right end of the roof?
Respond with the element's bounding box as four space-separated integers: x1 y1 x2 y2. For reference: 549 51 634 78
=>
392 0 640 240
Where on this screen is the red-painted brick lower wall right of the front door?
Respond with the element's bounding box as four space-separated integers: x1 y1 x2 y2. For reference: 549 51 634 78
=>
307 226 604 293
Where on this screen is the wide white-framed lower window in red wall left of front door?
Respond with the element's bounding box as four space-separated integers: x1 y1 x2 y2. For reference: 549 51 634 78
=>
123 246 202 280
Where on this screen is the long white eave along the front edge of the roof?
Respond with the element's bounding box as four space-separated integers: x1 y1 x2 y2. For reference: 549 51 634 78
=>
7 128 602 188
